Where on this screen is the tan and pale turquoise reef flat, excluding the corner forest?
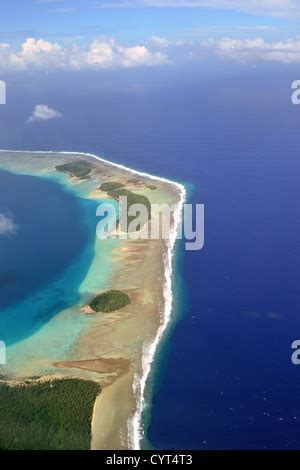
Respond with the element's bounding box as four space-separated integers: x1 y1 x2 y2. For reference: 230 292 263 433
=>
0 151 184 449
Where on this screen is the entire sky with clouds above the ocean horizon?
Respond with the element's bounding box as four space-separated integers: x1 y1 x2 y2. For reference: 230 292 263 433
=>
0 0 300 71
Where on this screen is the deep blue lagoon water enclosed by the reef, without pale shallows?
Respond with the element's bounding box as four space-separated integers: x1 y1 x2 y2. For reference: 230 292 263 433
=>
0 170 95 345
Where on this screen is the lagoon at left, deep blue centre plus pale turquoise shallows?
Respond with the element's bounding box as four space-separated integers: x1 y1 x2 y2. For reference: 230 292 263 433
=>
0 164 117 376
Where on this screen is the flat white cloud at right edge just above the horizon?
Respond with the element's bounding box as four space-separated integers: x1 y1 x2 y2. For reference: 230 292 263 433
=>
203 36 300 64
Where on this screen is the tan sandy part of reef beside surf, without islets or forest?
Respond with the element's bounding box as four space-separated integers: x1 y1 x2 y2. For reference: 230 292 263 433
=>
0 152 184 450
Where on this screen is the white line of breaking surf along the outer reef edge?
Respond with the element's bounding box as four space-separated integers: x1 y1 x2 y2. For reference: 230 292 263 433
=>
0 150 186 450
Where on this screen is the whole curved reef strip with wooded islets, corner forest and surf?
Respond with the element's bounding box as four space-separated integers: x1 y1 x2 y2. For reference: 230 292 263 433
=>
0 151 185 450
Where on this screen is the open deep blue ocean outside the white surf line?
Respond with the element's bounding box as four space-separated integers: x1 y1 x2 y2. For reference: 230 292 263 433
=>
0 65 300 449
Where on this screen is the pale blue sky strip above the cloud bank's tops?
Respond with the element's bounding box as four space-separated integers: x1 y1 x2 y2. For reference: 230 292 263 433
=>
0 0 300 44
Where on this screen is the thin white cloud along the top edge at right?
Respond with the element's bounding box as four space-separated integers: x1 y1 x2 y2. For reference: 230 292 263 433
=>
99 0 300 17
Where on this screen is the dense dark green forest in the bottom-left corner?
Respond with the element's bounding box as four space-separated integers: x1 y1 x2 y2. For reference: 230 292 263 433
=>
0 379 100 450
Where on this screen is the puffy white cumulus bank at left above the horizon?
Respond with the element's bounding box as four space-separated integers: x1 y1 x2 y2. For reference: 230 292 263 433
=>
0 38 168 70
